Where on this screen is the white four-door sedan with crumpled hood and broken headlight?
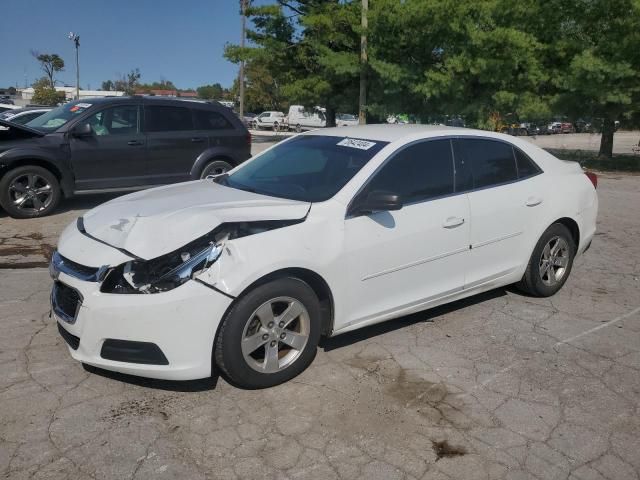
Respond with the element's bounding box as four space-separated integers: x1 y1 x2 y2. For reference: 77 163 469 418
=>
50 125 598 388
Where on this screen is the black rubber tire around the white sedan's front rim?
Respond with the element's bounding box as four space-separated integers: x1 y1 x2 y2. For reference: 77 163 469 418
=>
214 278 321 389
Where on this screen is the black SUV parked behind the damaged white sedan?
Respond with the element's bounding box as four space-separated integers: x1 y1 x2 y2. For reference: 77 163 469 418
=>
0 96 251 218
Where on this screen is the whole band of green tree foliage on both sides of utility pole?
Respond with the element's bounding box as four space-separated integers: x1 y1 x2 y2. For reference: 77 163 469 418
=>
225 0 640 156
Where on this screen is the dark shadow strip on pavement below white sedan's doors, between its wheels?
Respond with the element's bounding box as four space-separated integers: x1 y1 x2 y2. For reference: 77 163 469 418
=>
320 288 510 352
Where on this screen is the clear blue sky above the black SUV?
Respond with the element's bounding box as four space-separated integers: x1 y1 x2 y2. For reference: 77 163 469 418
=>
0 0 269 89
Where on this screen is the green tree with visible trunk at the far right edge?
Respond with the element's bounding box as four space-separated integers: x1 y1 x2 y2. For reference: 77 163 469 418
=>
550 0 640 158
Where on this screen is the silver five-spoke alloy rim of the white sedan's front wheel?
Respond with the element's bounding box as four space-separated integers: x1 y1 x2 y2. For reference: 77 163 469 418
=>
241 297 311 373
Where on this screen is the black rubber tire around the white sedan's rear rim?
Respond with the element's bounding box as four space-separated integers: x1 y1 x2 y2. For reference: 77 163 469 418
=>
517 223 576 297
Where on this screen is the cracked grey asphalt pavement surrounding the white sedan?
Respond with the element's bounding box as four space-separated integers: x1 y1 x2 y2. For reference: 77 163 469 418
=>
0 175 640 480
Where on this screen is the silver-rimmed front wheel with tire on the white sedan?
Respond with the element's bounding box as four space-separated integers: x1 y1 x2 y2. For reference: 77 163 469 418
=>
214 278 321 388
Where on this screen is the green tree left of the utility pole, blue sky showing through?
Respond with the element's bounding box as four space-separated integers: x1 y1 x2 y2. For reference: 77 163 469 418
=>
225 0 360 126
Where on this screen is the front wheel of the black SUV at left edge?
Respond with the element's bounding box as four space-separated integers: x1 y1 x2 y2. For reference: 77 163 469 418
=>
0 165 62 218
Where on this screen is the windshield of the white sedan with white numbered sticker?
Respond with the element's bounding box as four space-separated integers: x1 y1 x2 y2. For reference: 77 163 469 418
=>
218 135 387 202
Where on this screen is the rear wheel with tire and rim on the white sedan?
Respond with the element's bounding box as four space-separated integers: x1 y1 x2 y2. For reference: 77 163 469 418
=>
518 223 577 297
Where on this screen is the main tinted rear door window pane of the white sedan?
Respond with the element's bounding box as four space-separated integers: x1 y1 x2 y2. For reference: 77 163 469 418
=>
456 138 518 189
